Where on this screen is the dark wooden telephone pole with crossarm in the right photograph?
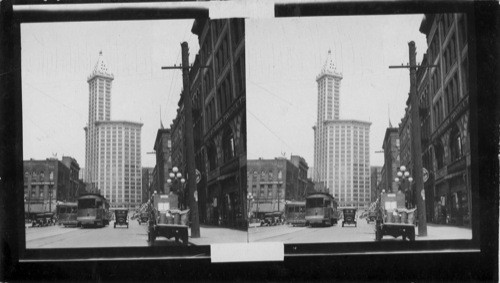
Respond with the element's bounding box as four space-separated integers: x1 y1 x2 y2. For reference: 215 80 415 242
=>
389 41 428 237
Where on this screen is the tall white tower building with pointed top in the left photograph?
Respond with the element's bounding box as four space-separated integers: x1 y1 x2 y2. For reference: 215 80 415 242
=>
84 52 142 210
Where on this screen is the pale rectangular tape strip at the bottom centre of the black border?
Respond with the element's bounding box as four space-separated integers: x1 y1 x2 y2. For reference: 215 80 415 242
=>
210 242 285 262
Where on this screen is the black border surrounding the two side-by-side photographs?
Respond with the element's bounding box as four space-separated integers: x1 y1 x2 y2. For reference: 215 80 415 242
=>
0 1 500 281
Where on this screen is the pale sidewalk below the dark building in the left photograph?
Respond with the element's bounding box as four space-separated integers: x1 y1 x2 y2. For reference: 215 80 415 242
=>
189 225 247 246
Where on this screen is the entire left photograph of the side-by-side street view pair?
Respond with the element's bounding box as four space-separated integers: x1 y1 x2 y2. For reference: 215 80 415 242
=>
21 18 248 249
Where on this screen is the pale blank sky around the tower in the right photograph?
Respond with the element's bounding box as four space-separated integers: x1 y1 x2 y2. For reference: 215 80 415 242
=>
245 15 427 167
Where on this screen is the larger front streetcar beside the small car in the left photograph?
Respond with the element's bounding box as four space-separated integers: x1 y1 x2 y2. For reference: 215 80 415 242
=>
76 194 110 227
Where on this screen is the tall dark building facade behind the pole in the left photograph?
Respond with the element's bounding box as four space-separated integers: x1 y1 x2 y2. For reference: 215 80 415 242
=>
171 19 247 229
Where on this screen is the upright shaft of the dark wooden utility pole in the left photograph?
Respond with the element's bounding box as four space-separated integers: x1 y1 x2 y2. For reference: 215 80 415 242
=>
181 41 200 238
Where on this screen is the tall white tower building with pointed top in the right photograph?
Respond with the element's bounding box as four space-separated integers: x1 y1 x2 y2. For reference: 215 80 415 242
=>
313 51 371 210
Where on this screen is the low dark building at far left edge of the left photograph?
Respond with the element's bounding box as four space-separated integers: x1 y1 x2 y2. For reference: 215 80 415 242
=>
23 157 79 218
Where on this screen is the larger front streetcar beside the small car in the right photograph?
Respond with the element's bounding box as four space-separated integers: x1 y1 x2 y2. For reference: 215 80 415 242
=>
305 193 339 226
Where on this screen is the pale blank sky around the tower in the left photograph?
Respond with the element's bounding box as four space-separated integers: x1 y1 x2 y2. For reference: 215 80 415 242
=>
21 20 199 167
